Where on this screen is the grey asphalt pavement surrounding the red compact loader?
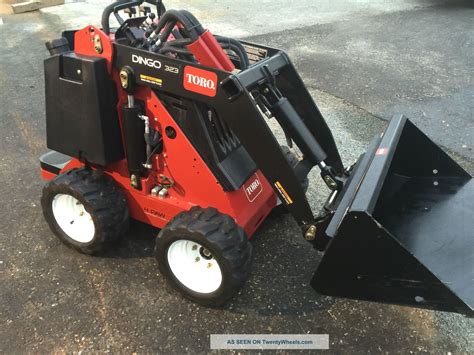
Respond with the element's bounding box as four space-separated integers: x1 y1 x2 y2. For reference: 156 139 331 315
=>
0 0 474 353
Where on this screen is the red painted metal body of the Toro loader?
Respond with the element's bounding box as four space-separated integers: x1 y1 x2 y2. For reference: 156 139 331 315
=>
41 26 277 237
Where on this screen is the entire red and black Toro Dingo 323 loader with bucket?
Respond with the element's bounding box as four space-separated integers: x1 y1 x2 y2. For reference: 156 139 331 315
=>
41 0 474 316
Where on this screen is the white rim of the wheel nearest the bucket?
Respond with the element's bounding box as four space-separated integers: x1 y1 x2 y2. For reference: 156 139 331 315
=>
168 239 222 293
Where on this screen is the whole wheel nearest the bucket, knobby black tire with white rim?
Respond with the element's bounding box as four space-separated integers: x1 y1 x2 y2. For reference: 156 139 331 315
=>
155 207 252 307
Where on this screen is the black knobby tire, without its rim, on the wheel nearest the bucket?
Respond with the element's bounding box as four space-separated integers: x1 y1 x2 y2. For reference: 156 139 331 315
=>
155 207 253 307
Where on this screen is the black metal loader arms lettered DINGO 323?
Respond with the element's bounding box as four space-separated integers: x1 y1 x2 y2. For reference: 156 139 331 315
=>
114 42 344 228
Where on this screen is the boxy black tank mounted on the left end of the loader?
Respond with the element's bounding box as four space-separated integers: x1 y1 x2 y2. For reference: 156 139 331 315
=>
44 52 124 166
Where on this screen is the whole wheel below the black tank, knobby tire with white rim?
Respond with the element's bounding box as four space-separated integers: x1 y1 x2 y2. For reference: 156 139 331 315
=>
41 168 129 254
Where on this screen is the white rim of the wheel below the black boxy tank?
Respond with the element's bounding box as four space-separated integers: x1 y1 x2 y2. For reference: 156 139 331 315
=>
52 194 95 243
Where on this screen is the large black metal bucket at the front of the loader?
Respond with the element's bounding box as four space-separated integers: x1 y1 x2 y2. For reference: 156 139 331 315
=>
312 116 474 317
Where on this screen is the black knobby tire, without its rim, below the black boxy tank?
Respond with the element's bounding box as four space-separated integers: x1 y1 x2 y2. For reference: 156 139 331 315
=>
41 168 130 254
